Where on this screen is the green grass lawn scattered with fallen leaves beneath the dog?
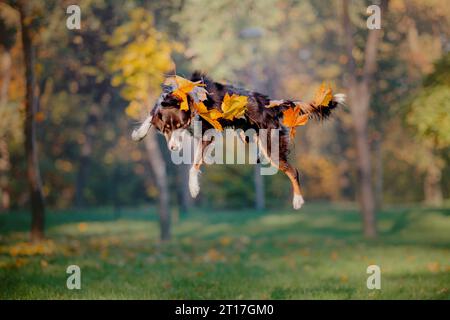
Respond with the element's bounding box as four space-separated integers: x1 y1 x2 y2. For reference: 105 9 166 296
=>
0 204 450 299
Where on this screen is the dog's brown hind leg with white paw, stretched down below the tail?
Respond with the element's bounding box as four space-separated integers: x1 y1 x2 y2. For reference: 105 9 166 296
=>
258 135 305 210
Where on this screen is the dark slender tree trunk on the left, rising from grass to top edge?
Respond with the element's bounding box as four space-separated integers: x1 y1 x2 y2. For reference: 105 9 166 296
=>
19 2 45 241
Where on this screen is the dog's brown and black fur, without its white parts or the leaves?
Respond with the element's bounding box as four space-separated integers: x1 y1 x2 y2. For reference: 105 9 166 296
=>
141 72 339 209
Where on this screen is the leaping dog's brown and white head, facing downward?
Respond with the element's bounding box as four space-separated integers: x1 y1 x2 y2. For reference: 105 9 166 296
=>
151 92 191 151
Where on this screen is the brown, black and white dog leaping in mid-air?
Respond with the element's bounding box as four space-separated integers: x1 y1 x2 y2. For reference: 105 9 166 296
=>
132 72 345 209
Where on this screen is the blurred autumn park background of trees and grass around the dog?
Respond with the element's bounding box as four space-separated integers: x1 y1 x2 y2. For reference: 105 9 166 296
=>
0 0 450 299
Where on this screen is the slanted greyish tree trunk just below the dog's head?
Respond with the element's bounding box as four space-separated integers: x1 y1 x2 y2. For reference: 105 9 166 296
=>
145 130 170 241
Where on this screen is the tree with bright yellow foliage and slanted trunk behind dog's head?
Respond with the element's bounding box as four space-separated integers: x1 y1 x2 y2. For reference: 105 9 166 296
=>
107 8 179 240
